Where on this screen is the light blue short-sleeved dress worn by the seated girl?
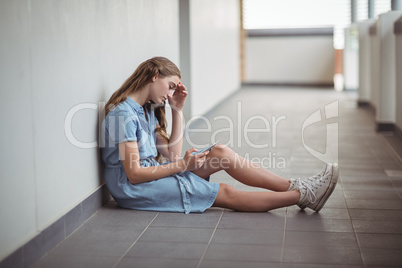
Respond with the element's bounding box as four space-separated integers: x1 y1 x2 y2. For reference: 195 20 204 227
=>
101 97 219 214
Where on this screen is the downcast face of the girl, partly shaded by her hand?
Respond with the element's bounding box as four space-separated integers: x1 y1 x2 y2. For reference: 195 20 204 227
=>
149 76 180 104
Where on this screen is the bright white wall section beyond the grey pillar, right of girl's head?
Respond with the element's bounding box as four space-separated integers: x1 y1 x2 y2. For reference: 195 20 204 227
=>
189 0 240 115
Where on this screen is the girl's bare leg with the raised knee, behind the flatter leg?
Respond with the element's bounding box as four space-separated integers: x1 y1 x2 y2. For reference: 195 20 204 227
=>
193 145 290 192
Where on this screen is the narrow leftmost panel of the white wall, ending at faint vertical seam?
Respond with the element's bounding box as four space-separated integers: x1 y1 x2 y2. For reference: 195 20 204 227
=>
0 1 37 259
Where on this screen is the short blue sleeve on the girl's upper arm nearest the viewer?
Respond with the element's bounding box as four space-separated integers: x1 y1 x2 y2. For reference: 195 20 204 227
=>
106 111 138 143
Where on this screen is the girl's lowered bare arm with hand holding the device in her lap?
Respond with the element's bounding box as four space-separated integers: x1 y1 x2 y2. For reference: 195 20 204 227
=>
119 141 208 184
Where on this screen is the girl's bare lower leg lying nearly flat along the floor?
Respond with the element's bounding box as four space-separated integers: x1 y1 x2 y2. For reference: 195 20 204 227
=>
212 183 300 212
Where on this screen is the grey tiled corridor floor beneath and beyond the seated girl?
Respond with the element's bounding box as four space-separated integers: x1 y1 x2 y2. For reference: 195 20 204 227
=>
36 88 402 268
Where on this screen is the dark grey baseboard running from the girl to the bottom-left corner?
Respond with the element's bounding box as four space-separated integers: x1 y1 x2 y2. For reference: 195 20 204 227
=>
0 184 110 268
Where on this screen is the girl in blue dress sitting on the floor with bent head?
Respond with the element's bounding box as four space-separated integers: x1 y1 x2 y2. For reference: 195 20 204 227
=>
102 57 338 213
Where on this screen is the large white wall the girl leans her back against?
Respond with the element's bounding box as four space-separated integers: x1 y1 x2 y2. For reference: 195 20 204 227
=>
0 0 179 260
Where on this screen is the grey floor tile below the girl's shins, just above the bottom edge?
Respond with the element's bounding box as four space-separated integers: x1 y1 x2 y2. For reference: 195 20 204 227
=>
204 244 282 262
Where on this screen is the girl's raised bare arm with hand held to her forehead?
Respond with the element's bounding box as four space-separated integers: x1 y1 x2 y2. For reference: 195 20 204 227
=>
157 83 188 162
